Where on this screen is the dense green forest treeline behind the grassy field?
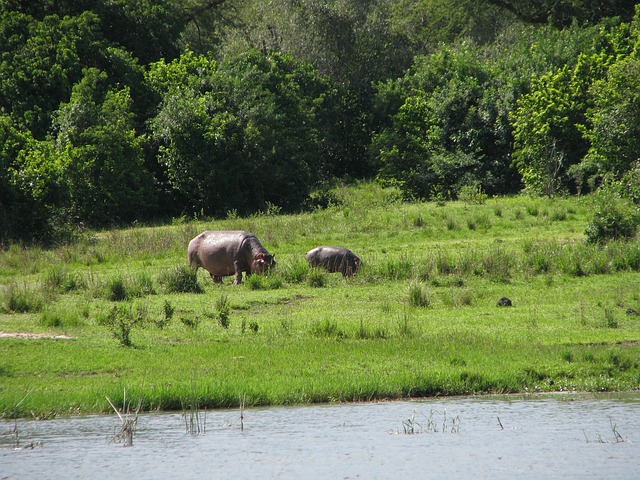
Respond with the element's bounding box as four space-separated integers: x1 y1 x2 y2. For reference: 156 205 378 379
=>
0 0 640 244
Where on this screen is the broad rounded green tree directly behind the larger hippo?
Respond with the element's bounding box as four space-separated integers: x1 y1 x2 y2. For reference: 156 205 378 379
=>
149 51 340 214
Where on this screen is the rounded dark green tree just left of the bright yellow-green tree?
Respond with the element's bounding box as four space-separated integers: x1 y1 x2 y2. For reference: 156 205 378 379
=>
373 47 519 199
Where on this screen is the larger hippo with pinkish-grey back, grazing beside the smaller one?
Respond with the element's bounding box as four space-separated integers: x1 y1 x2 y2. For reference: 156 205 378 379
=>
187 230 276 285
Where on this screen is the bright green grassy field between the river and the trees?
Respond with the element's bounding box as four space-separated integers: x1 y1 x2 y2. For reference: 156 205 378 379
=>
0 183 640 418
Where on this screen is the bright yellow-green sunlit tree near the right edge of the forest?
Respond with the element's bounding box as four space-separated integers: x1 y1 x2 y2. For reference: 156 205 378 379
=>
512 15 637 195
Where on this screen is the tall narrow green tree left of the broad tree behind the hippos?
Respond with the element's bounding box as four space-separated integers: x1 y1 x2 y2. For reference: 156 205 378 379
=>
55 69 155 225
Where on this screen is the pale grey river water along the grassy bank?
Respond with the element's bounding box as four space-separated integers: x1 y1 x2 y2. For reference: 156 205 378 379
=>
0 394 640 480
